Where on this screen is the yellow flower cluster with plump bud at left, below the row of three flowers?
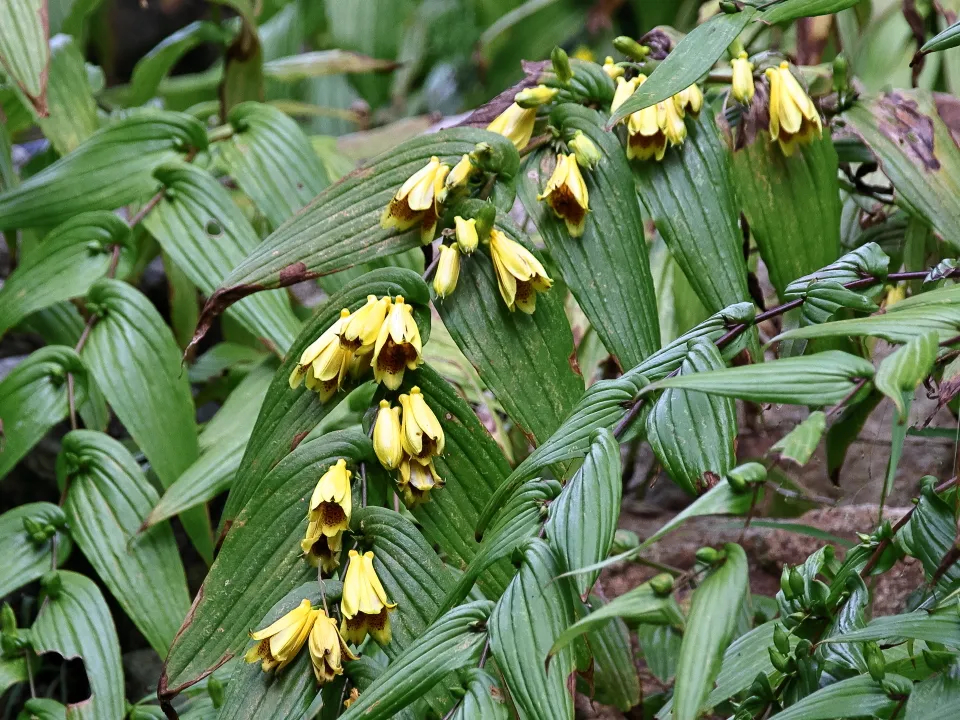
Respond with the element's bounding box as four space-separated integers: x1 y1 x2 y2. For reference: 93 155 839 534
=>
373 387 445 507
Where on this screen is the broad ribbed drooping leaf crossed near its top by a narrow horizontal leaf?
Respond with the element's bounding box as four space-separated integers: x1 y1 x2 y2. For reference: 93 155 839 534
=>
647 340 737 495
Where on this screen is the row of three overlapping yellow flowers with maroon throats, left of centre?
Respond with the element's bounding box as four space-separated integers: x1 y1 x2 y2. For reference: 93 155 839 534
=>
290 295 423 402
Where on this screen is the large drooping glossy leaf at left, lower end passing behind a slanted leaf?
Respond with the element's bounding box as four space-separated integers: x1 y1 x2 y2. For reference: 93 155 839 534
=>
83 279 213 560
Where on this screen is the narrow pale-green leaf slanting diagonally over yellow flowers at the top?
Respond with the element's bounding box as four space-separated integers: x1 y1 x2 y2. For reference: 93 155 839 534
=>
610 7 757 124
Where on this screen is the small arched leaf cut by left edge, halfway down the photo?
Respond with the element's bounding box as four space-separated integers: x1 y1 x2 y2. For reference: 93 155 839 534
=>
0 345 87 480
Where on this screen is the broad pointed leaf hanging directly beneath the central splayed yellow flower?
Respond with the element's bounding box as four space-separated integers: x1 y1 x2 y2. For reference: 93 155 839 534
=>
435 213 583 445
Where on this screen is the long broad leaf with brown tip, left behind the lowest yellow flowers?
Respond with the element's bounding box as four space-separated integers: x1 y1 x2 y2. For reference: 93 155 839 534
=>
158 430 372 700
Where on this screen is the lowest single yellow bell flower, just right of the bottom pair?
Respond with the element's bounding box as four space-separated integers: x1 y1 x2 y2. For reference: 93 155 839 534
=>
340 550 397 645
